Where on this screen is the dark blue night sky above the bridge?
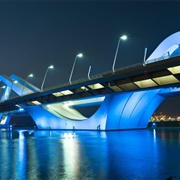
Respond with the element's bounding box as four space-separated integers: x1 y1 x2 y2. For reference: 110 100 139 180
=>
0 1 180 115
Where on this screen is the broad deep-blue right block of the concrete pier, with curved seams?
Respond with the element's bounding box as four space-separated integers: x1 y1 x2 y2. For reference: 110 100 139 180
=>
106 89 165 130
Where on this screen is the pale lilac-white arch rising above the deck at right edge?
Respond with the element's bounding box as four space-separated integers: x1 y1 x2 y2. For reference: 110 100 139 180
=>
146 31 180 64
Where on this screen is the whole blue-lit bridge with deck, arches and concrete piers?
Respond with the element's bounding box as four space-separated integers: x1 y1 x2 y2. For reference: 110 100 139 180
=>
0 32 180 130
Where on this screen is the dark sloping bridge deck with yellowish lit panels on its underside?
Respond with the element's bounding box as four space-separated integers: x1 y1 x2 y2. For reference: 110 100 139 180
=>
0 56 180 112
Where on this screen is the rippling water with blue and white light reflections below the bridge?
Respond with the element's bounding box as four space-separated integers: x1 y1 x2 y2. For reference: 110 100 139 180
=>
0 128 180 180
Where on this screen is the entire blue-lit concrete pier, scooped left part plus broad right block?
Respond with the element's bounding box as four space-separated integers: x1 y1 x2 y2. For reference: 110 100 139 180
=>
21 89 165 130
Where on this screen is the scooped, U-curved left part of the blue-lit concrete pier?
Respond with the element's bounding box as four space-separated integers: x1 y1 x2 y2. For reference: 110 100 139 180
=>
25 95 112 130
